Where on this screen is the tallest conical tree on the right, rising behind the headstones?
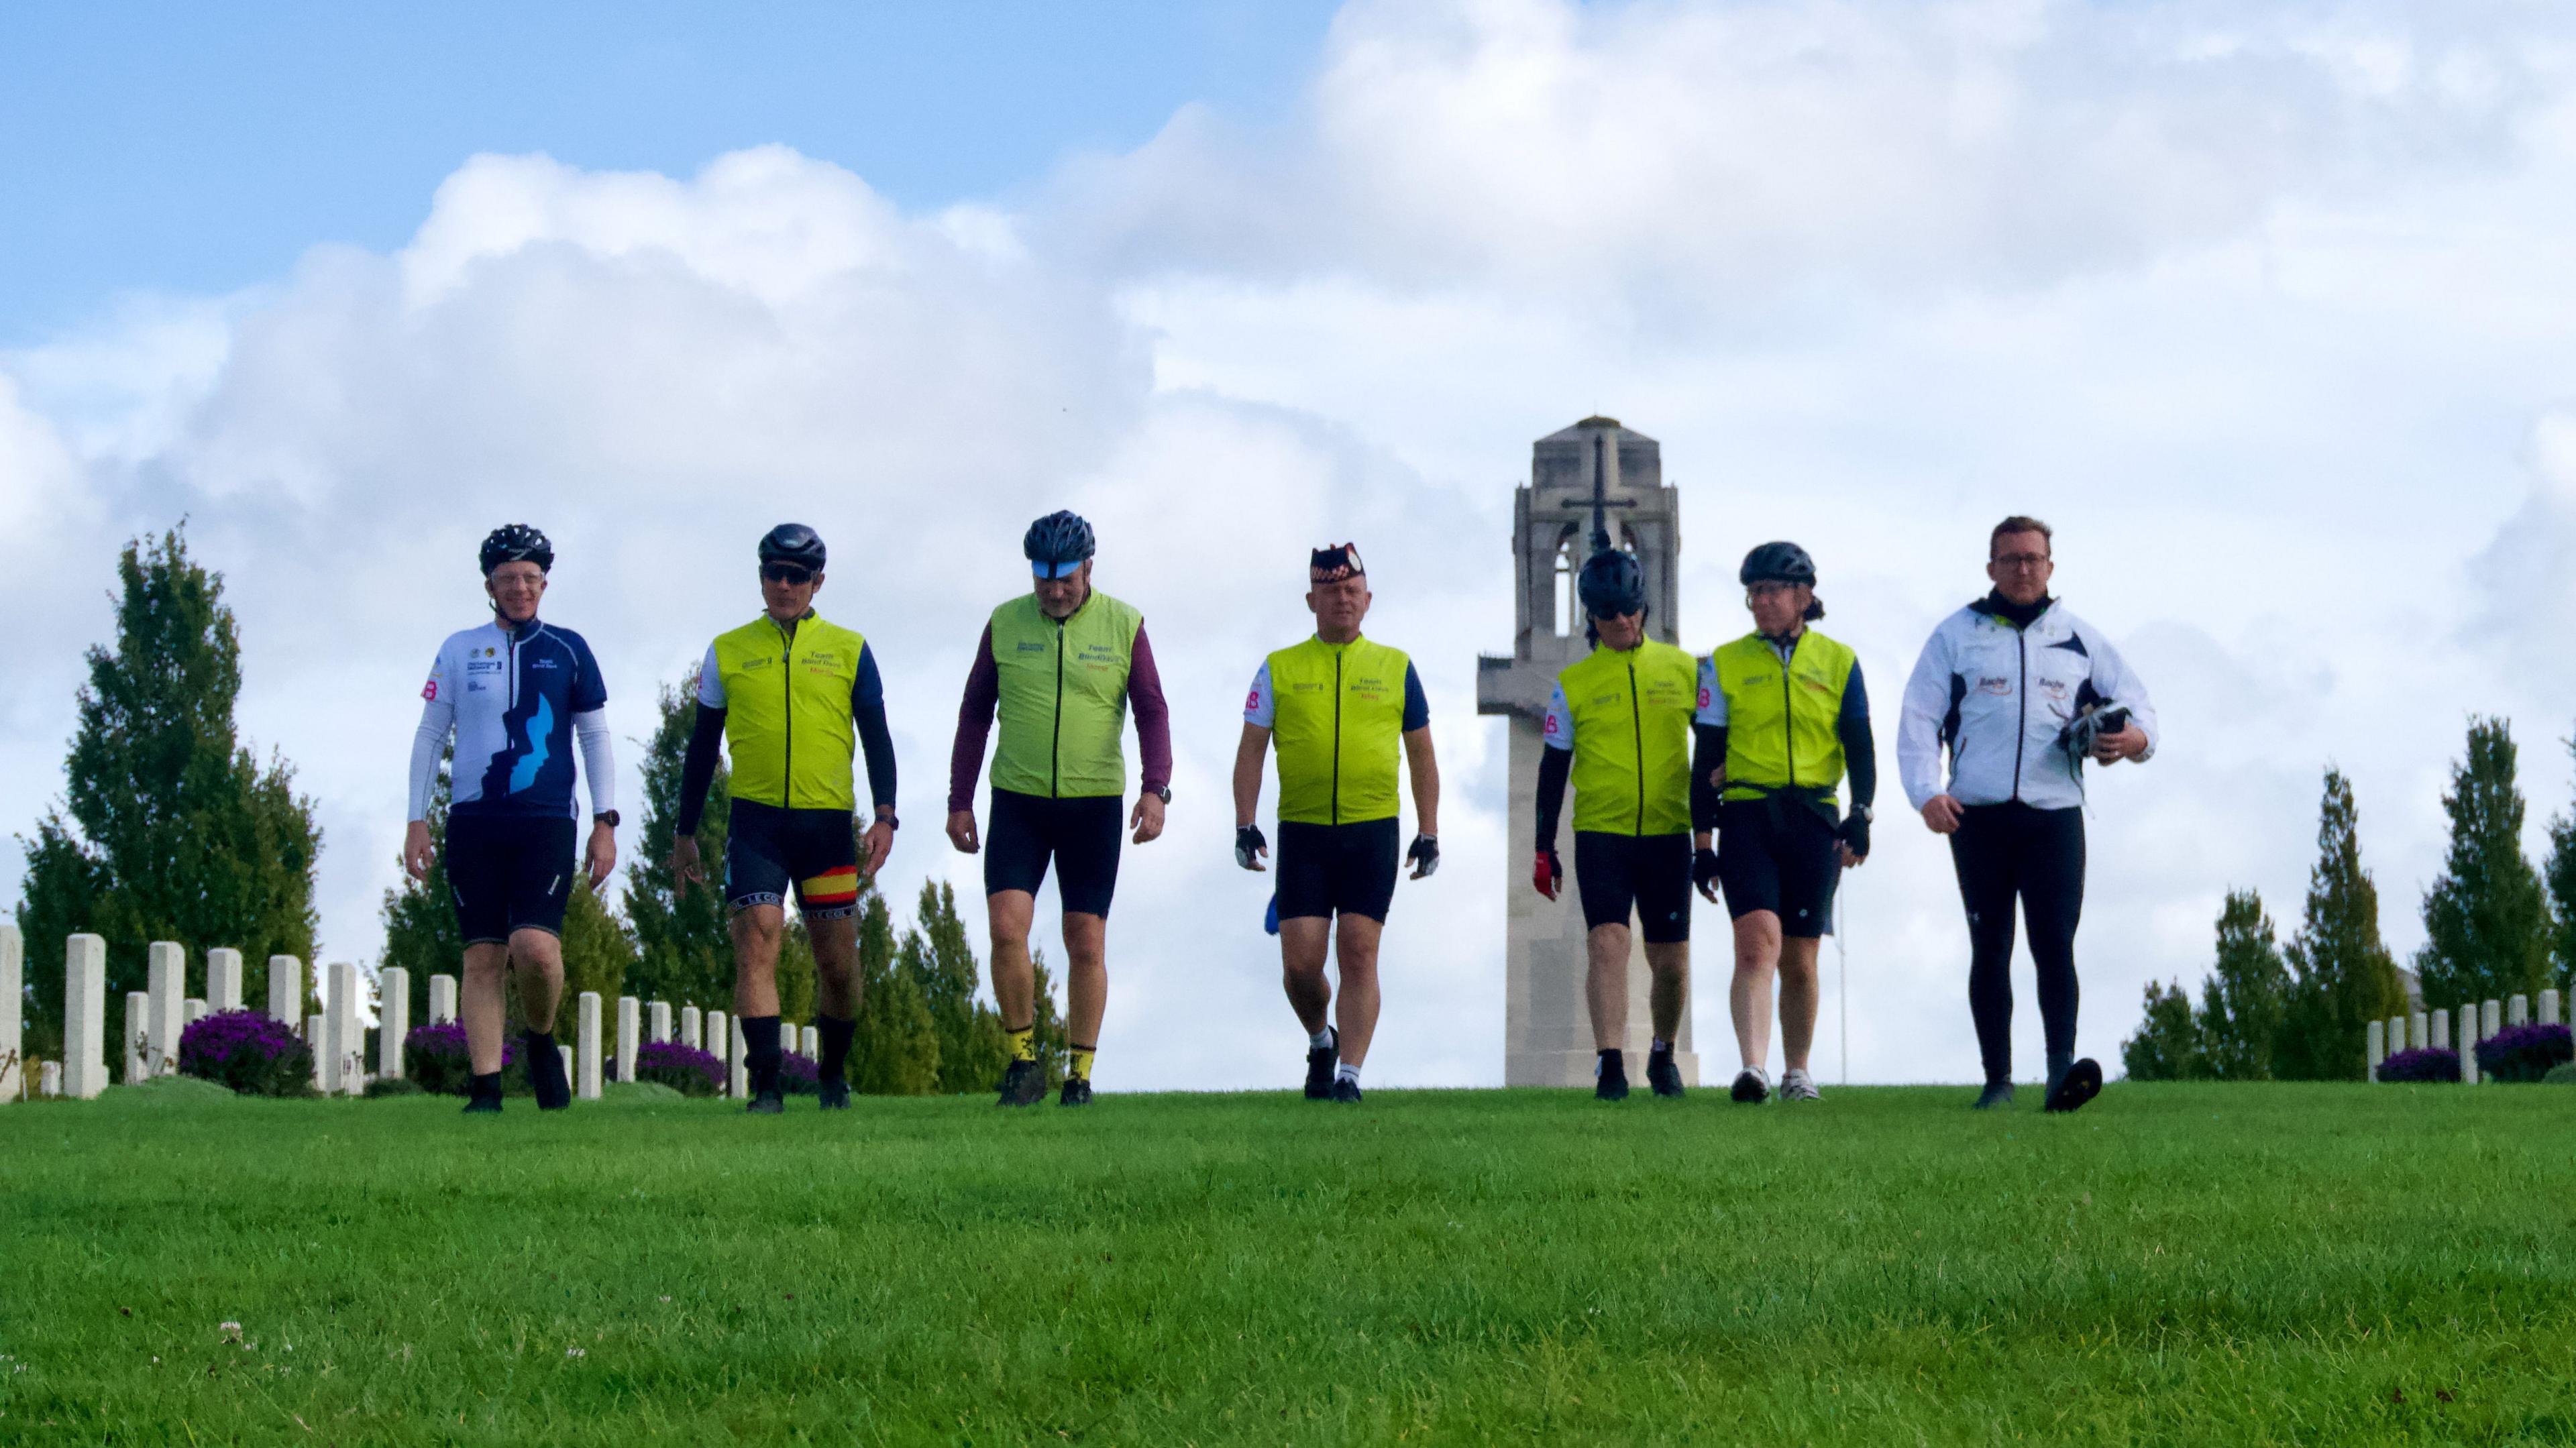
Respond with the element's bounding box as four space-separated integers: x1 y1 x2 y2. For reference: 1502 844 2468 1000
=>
2416 719 2551 1005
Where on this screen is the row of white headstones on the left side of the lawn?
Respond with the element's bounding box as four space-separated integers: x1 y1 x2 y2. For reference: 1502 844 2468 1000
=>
0 925 819 1103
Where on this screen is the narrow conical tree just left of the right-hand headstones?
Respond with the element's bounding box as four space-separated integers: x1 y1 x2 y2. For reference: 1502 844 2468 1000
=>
2272 768 2406 1082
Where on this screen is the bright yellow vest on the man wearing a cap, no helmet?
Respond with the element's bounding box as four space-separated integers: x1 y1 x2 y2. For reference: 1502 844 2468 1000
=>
1270 639 1407 824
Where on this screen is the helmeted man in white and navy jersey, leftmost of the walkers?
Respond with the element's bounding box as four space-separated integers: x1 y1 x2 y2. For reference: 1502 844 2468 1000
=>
402 523 619 1113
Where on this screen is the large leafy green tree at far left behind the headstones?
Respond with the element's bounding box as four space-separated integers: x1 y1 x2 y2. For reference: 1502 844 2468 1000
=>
18 528 322 1044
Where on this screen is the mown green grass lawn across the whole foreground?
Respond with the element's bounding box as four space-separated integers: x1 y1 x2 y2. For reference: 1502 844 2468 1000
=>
0 1084 2576 1443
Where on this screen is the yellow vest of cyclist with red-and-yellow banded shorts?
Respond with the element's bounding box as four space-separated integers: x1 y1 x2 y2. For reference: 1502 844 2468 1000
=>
716 613 865 812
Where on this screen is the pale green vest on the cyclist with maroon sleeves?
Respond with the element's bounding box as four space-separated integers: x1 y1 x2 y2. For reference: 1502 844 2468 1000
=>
991 593 1144 799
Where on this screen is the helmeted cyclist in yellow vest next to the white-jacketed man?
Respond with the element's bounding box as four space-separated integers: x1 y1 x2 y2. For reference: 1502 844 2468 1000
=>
1690 544 1878 1103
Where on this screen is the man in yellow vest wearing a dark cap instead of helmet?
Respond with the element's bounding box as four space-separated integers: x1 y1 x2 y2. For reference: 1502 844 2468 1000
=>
1234 544 1440 1103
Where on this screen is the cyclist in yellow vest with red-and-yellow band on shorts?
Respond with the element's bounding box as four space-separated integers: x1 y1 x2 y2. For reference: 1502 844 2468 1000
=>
672 523 894 1115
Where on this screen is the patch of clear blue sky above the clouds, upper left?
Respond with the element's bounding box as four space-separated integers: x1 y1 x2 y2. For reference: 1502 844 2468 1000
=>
0 0 1332 348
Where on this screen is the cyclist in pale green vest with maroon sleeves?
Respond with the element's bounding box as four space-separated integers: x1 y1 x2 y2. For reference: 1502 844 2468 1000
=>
948 512 1172 1105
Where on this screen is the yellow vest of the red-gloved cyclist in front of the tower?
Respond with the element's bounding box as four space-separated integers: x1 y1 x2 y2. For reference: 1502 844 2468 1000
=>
1556 639 1700 835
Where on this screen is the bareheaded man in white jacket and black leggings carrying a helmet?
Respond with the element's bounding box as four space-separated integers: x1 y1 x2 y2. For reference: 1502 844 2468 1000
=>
1896 515 2156 1111
